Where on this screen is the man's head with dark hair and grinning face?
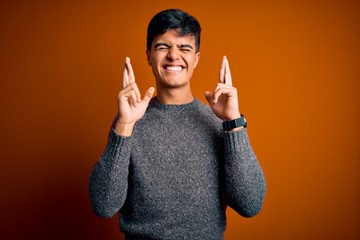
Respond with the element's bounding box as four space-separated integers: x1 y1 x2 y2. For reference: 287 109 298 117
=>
146 9 201 90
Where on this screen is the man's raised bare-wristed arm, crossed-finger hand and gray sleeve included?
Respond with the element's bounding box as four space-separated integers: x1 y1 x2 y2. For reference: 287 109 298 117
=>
89 58 154 217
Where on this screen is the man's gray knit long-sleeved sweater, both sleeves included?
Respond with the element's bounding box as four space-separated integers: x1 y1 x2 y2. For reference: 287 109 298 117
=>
89 98 266 240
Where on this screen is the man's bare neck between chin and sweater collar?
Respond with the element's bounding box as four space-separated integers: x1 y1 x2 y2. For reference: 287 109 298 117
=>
156 86 194 104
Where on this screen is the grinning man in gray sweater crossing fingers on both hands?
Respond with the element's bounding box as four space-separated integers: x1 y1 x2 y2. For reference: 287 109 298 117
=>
89 9 266 240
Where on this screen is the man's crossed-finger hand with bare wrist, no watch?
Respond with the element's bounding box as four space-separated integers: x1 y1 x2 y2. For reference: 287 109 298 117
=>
115 57 155 136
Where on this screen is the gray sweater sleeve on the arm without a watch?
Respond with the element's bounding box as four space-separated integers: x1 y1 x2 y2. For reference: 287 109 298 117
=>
89 129 131 218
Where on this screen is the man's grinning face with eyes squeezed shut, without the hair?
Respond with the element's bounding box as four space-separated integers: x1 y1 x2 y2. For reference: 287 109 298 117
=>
147 29 200 88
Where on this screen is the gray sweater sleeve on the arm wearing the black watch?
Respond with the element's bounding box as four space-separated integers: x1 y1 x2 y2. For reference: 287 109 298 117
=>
224 129 266 217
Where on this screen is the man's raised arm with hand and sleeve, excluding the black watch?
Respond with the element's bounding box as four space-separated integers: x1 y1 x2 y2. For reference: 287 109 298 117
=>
205 57 266 217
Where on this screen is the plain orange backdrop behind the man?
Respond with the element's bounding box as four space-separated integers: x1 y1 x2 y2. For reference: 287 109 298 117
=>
0 0 360 240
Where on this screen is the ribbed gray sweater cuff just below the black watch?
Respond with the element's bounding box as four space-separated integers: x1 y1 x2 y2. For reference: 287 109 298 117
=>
224 128 251 153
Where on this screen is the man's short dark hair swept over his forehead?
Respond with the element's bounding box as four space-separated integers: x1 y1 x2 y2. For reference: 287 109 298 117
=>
146 9 201 52
